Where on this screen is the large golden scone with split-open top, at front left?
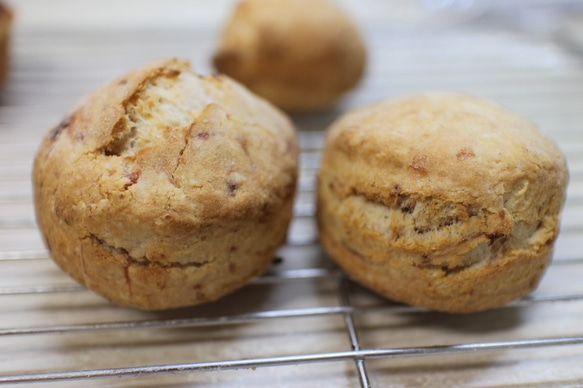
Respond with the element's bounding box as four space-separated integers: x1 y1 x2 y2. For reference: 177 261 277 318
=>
33 59 298 310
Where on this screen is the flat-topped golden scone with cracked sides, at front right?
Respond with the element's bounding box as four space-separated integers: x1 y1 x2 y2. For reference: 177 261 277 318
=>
318 93 568 313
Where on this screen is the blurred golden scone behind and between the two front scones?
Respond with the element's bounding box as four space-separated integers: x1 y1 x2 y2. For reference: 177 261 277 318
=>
214 0 366 112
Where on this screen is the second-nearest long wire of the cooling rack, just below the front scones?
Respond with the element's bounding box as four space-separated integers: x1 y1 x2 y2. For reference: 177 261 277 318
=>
0 294 583 338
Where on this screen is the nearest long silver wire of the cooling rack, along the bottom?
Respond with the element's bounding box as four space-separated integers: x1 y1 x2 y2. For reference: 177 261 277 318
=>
0 336 583 384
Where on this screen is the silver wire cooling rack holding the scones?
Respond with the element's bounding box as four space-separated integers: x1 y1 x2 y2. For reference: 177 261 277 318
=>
0 2 583 387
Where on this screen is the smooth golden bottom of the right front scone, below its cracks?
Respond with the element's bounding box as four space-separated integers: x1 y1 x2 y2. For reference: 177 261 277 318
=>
320 208 551 313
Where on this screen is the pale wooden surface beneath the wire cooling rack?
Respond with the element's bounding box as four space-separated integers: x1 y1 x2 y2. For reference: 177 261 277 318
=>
0 0 583 387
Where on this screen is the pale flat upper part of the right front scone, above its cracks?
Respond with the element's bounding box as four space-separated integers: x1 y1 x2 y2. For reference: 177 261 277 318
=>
328 93 566 207
